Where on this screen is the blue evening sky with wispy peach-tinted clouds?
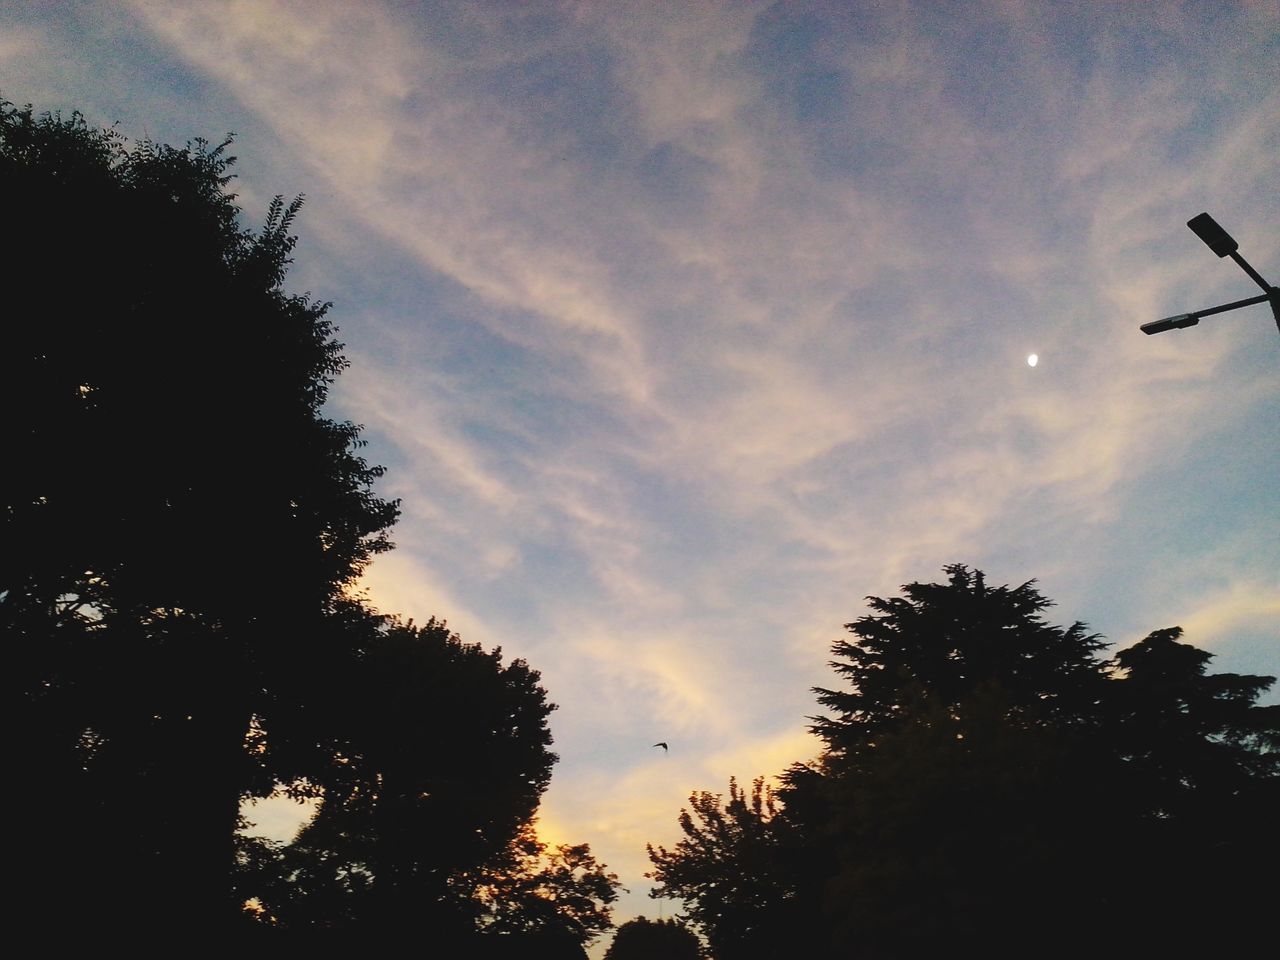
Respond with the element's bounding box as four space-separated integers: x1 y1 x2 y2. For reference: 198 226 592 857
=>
0 0 1280 955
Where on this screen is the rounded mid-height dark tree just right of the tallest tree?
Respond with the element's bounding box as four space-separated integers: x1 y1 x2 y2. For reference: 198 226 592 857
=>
249 620 556 924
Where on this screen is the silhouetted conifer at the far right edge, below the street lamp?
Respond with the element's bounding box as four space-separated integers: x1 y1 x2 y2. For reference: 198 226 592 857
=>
1108 627 1280 955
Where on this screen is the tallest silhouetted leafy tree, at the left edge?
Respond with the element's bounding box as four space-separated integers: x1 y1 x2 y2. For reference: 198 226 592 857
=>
0 102 397 927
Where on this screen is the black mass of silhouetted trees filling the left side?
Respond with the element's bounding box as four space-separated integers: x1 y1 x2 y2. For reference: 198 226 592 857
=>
0 102 617 956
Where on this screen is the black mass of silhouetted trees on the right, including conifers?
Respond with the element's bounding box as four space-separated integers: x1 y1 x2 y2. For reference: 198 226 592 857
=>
649 564 1280 960
